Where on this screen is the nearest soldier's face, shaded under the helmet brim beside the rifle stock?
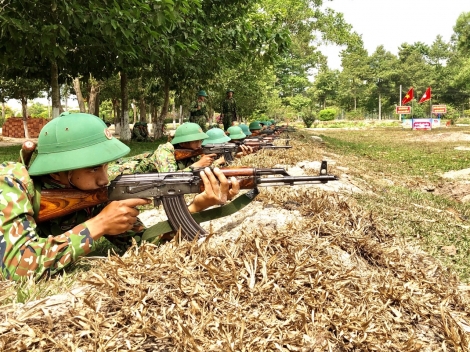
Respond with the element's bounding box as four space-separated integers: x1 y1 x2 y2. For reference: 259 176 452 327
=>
51 164 109 191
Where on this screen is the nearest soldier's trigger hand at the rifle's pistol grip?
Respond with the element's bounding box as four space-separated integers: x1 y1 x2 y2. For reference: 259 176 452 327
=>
85 198 151 239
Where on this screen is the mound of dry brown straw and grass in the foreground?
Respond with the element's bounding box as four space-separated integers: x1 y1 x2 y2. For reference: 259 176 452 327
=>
0 133 470 351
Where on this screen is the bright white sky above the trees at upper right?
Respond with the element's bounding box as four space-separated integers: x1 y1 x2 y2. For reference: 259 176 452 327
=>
322 0 470 69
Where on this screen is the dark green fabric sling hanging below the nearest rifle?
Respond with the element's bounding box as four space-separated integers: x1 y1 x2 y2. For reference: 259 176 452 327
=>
142 188 259 242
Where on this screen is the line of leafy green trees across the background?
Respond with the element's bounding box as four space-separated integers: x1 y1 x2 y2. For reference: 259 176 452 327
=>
0 0 470 141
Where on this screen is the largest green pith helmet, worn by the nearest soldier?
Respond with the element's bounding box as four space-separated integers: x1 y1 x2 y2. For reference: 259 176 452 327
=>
28 112 130 176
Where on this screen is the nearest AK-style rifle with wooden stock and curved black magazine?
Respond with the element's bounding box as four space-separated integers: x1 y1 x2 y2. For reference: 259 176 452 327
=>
36 161 338 240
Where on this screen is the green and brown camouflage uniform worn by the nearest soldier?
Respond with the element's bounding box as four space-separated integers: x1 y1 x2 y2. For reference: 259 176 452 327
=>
0 162 149 280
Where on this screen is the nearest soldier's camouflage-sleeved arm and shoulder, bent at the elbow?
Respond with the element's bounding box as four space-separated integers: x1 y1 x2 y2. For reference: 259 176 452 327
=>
0 163 95 280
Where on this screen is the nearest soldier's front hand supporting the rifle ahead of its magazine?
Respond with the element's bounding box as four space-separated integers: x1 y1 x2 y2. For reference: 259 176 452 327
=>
188 168 240 213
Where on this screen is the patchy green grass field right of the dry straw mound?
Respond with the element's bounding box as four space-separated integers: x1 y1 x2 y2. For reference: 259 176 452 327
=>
319 127 470 282
